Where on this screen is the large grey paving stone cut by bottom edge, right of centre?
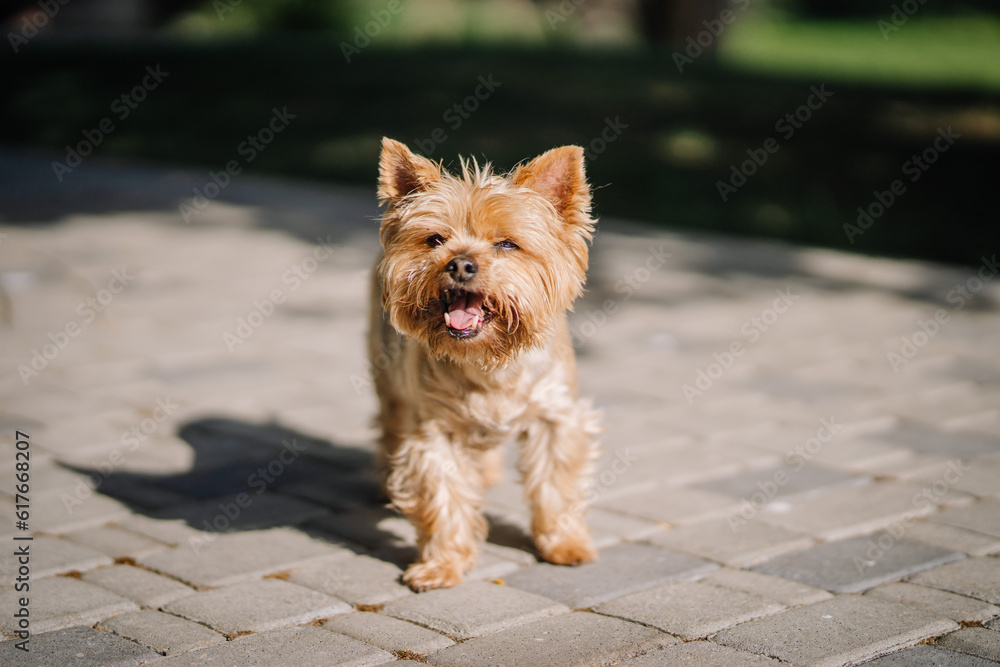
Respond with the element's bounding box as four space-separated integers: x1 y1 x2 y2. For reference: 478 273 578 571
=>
711 595 958 667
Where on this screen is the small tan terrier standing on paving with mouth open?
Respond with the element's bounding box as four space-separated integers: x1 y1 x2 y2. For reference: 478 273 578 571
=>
369 138 600 591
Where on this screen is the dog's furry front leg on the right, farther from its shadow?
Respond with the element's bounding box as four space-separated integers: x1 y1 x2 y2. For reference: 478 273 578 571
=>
518 403 599 565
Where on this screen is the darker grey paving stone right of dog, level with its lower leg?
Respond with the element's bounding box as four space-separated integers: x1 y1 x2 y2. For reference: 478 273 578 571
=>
695 464 859 500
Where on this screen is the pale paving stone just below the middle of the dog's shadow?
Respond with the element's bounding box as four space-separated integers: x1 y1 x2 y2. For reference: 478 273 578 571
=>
139 528 352 587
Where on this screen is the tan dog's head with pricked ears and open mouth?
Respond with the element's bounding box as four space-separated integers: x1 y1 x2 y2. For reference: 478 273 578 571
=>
377 139 594 368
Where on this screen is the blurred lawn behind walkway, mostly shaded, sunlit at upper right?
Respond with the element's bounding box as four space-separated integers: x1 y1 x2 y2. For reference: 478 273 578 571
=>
0 9 1000 264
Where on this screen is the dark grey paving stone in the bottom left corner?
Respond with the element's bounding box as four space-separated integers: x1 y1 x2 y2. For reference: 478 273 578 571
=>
0 626 159 667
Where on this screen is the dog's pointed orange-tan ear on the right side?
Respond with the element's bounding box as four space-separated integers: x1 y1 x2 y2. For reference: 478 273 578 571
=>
511 146 592 226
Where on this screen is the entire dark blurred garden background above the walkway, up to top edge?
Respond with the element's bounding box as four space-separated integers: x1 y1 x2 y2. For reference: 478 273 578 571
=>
0 0 1000 264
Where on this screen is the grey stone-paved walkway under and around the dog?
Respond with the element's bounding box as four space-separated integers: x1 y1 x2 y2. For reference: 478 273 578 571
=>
0 154 1000 667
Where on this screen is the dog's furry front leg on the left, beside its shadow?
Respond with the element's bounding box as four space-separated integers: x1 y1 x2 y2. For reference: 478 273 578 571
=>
387 425 486 591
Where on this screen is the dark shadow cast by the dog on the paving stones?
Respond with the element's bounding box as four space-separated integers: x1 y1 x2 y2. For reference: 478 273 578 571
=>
63 417 537 568
